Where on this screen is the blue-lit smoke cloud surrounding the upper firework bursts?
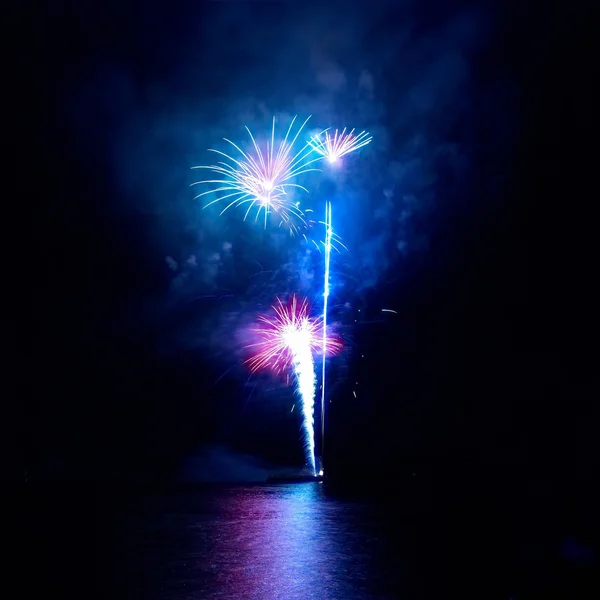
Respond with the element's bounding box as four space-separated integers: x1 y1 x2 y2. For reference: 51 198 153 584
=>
55 2 513 354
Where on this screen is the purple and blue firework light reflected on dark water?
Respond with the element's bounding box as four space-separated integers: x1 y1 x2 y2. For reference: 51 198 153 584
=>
121 483 391 600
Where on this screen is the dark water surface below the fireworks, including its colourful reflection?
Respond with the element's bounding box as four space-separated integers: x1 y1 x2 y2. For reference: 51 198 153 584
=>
29 477 600 600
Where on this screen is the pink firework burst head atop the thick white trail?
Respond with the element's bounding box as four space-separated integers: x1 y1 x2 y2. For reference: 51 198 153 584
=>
246 295 343 374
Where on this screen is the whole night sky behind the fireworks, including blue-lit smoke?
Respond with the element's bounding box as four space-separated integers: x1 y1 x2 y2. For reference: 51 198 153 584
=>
21 0 599 480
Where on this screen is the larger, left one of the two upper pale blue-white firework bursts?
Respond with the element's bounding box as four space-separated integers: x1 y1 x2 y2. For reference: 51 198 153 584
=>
192 117 322 235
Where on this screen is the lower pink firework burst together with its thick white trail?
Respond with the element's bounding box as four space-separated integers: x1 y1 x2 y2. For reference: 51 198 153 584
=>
246 296 342 474
